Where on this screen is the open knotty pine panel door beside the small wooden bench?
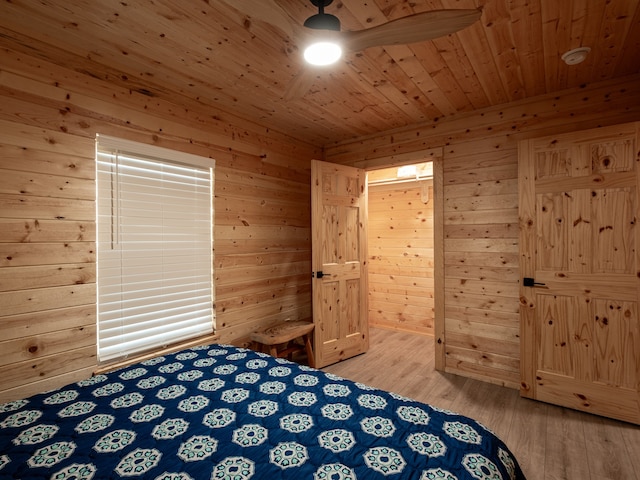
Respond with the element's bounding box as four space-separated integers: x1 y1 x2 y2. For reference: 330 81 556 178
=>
311 160 369 368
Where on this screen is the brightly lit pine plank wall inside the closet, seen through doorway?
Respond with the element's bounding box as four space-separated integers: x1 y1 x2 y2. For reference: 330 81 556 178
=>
368 180 434 335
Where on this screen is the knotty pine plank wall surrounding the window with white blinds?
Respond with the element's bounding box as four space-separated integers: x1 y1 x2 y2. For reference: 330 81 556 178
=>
0 44 322 402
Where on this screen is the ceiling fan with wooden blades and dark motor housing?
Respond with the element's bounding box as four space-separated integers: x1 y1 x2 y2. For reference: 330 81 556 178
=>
219 0 482 100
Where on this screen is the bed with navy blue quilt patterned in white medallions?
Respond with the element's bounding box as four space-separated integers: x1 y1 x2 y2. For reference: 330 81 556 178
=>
0 345 524 480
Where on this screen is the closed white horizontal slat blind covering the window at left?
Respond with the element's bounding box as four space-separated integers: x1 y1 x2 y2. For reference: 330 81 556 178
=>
96 136 215 361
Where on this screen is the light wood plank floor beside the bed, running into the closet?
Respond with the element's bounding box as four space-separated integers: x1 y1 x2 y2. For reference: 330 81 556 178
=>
323 329 640 480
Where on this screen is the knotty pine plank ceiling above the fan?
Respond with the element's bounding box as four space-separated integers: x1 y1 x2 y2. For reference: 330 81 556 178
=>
0 0 640 146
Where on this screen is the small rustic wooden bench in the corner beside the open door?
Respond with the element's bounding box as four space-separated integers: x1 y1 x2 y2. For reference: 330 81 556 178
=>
251 320 315 367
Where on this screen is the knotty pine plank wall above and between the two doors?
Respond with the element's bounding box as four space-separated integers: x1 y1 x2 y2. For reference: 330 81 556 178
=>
325 75 640 388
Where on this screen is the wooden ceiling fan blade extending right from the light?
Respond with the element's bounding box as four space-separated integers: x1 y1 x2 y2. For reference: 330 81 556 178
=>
341 9 482 52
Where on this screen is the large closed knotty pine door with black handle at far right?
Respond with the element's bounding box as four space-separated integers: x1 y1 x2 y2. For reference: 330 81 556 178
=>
519 123 640 423
